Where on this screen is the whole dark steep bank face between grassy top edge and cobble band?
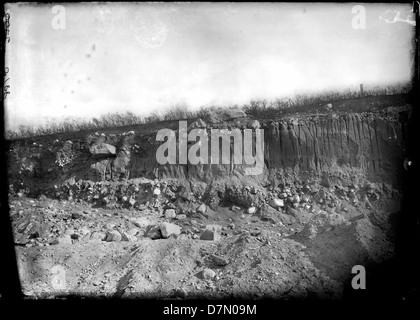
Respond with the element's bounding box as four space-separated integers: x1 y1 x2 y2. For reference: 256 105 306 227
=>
8 108 405 195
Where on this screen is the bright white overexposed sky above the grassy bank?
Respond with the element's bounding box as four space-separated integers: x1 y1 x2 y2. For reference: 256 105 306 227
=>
5 3 414 128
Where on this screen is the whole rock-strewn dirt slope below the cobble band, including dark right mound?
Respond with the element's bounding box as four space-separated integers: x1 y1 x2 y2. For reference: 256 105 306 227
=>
10 181 398 299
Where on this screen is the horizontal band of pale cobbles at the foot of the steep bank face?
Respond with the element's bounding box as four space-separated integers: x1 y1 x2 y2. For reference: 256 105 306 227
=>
17 170 399 230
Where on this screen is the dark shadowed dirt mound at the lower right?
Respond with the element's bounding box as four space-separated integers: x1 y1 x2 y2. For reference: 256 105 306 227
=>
291 211 394 282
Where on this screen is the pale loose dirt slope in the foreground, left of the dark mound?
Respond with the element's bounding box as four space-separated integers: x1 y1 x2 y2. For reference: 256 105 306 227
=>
13 192 342 298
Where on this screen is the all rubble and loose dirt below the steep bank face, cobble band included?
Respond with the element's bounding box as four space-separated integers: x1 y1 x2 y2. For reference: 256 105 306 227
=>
9 172 393 298
